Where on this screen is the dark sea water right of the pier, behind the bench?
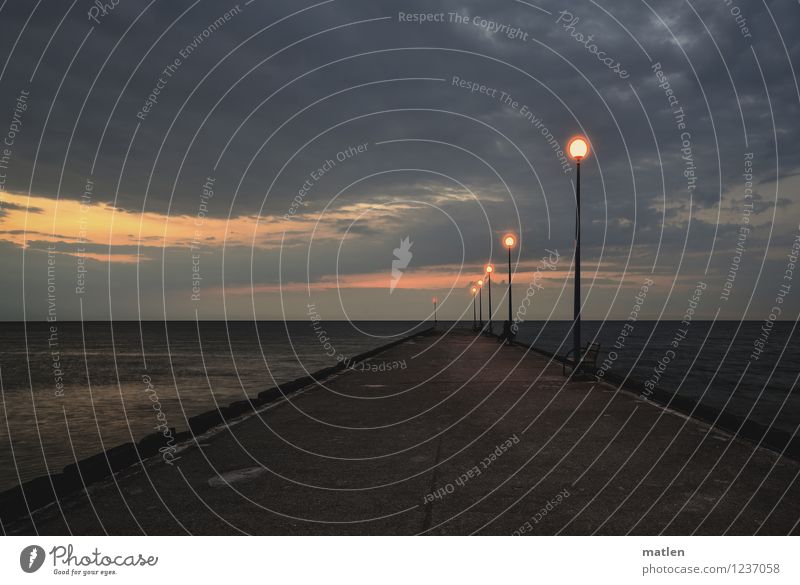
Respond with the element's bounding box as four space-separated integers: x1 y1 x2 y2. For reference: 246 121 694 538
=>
517 321 800 434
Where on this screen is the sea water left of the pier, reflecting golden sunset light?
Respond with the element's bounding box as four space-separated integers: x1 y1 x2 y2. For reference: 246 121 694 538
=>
0 321 418 491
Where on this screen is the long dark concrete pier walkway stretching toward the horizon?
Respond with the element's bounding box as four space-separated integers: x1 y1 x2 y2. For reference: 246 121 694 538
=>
6 330 800 535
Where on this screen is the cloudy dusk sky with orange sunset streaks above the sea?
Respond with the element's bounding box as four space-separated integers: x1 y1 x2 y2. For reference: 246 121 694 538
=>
0 0 800 321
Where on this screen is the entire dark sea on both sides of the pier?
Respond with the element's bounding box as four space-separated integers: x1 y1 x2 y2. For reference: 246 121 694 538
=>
0 321 800 491
